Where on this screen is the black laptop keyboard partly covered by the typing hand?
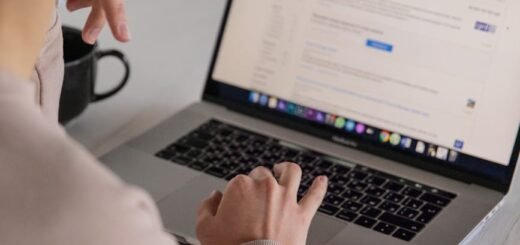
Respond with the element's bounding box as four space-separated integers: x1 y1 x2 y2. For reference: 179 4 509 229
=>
156 120 457 241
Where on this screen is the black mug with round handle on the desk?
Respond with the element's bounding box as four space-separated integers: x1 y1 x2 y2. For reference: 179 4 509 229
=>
59 26 130 125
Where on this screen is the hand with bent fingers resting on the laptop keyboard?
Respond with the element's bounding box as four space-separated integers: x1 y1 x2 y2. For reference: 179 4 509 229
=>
197 163 328 245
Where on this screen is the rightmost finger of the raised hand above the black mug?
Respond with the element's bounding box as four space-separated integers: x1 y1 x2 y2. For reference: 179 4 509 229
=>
101 0 130 42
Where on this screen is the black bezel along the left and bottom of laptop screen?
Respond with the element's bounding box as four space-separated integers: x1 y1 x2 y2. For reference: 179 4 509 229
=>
202 0 520 193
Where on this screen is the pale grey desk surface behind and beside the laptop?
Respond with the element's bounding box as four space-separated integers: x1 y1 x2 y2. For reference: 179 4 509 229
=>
61 0 520 244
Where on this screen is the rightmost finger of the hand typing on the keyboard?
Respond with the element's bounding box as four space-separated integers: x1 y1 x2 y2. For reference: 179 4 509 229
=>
300 176 328 216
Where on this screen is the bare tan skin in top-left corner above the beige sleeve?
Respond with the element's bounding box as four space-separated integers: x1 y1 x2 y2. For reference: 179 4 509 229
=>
0 0 56 79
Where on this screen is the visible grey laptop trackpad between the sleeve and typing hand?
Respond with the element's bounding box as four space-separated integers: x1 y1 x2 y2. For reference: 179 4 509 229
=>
158 175 226 238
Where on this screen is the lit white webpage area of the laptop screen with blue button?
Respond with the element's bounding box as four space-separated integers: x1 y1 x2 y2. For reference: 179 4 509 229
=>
213 0 520 165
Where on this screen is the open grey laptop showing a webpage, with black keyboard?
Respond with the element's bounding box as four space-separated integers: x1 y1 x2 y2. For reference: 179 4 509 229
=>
101 0 520 245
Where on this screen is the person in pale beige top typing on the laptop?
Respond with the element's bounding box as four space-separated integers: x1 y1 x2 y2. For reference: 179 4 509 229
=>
0 0 327 245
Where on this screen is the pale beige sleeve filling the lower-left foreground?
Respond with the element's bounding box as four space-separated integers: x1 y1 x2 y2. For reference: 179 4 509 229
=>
0 71 176 245
